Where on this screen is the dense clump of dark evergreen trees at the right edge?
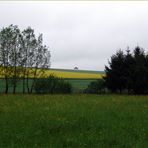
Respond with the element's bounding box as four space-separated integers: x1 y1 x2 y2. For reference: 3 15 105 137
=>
104 46 148 94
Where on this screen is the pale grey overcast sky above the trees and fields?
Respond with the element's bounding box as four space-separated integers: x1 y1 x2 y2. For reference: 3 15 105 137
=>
0 1 148 70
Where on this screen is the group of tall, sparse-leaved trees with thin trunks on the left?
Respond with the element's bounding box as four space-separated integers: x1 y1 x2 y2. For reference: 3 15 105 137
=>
0 25 50 94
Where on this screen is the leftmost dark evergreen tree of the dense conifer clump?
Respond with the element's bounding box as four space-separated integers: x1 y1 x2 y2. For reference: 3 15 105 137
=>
104 50 126 93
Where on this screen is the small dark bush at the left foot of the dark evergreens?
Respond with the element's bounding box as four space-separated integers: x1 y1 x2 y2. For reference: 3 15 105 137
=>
84 79 106 94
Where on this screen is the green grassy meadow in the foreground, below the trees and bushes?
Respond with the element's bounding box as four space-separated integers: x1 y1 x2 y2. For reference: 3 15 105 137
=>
0 95 148 148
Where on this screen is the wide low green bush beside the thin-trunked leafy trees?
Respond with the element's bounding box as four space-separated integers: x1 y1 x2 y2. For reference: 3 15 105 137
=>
35 75 72 94
